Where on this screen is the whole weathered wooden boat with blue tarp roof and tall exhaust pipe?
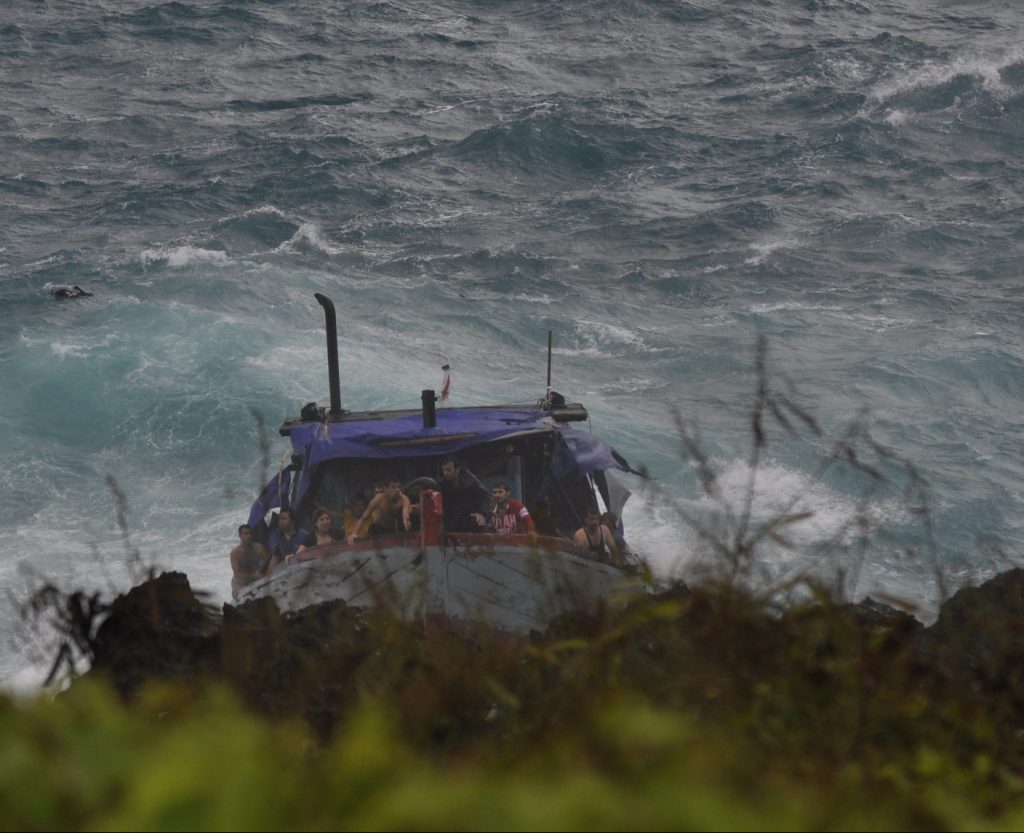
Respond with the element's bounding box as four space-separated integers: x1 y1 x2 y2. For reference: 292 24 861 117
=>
237 294 647 633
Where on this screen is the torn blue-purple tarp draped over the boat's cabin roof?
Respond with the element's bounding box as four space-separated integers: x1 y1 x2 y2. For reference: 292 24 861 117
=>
250 408 633 524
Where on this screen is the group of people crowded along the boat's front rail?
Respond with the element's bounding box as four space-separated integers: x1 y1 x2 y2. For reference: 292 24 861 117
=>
230 457 626 592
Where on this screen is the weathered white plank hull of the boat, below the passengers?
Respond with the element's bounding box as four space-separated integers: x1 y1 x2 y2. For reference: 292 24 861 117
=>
237 535 647 634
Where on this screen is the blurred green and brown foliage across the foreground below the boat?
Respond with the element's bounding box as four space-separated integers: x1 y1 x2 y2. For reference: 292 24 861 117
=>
0 573 1024 830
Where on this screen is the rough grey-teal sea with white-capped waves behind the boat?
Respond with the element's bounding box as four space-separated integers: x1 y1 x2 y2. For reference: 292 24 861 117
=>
0 0 1024 685
